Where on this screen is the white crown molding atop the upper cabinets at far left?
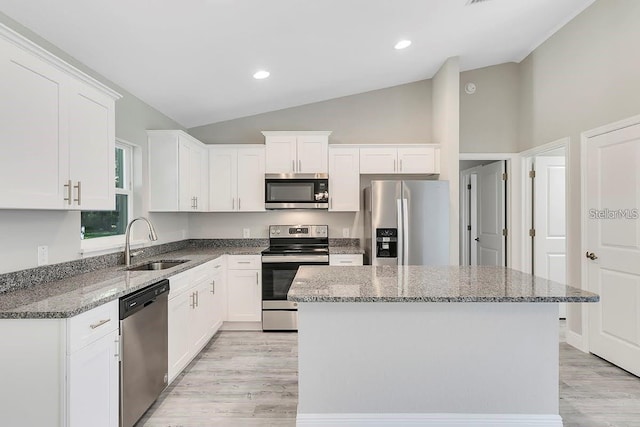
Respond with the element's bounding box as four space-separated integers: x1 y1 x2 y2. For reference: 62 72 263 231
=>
0 24 122 100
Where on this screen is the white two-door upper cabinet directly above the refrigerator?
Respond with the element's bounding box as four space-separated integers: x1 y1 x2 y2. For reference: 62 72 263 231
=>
360 144 440 174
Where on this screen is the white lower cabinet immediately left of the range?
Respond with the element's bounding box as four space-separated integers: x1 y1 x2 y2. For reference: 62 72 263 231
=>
227 255 262 322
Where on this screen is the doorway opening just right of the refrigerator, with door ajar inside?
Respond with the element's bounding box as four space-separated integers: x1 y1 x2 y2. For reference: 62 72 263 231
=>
460 159 508 266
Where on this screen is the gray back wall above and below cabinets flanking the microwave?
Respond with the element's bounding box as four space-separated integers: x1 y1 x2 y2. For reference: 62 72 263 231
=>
189 80 432 246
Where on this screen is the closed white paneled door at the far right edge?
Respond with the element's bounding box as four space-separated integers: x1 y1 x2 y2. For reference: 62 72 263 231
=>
583 124 640 375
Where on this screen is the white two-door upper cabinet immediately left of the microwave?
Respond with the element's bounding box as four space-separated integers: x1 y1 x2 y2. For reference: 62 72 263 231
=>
209 144 265 212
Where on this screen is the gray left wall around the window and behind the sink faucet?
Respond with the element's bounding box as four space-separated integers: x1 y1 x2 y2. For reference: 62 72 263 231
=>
0 12 188 273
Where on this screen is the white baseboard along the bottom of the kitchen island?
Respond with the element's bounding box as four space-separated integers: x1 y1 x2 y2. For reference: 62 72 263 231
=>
296 414 562 427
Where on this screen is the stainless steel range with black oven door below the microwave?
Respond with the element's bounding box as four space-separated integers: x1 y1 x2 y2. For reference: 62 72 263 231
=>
262 225 329 331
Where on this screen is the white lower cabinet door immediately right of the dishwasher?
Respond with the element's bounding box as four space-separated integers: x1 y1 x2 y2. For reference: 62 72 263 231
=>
167 290 193 382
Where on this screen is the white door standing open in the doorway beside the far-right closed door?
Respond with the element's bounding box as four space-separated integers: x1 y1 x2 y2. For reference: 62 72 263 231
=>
533 156 567 318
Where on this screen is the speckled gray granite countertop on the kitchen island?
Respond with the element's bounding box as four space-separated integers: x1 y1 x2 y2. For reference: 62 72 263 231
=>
287 265 600 303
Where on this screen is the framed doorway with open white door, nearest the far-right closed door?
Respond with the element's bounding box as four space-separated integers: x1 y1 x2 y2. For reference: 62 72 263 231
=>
522 138 569 319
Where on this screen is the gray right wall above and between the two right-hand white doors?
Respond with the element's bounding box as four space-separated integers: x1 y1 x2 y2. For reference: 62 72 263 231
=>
519 0 640 340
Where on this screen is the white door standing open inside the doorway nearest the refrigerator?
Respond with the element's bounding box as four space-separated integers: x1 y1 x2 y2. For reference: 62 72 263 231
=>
476 161 505 265
